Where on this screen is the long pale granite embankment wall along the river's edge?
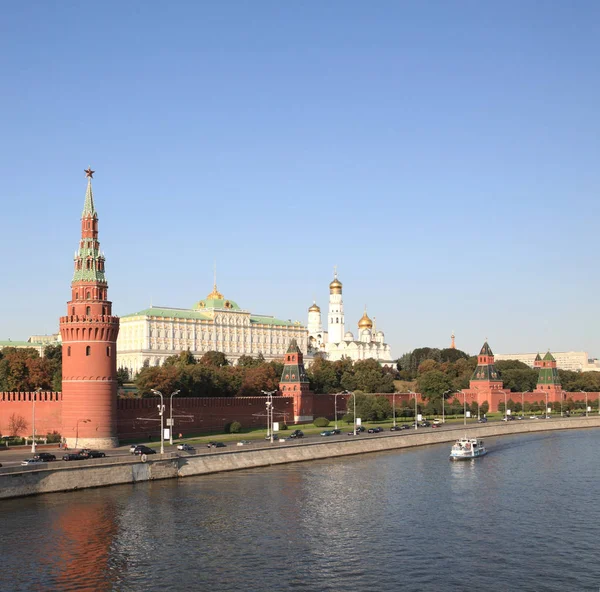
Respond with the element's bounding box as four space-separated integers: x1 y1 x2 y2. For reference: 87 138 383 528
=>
0 416 600 499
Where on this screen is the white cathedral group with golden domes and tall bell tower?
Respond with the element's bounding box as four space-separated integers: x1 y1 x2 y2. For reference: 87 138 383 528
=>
307 271 394 366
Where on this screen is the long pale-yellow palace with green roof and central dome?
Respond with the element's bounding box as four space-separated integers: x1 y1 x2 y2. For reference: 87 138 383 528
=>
117 284 308 376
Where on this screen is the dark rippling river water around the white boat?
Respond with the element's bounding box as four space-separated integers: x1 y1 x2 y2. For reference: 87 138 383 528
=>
0 430 600 592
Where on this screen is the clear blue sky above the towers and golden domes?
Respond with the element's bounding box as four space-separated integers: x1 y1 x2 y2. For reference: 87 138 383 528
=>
0 0 600 356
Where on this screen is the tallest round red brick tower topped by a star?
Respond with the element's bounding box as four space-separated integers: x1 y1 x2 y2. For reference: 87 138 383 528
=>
60 169 119 448
